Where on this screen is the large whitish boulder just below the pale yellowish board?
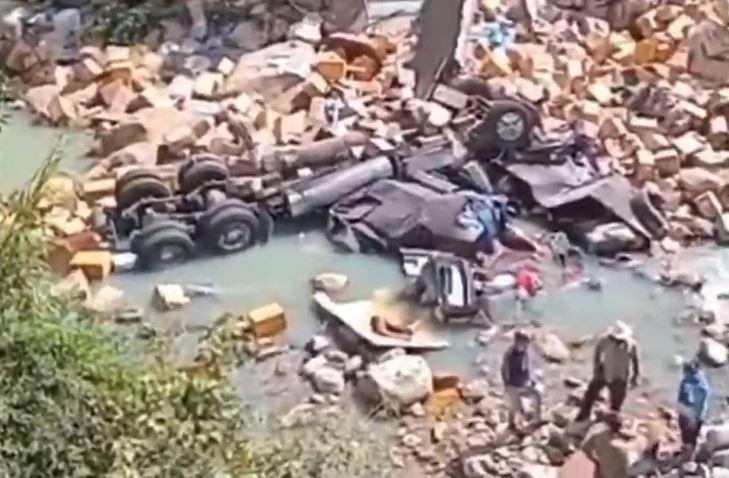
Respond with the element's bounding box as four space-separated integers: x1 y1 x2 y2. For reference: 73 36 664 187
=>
360 355 433 409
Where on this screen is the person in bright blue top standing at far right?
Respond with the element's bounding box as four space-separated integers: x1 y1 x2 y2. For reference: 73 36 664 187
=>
678 361 711 461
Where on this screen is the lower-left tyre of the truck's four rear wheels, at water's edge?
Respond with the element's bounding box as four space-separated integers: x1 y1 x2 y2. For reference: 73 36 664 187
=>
131 220 195 270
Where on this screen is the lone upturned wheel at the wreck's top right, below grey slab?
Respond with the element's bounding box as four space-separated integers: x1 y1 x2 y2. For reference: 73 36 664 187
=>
479 100 534 149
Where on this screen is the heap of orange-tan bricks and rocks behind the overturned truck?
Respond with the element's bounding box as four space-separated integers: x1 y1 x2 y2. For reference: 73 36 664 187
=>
3 0 729 246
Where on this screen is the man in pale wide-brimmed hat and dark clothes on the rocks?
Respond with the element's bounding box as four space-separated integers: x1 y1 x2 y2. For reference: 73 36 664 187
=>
576 321 640 422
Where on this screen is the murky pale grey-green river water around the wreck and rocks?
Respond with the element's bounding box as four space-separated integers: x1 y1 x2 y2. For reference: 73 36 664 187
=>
0 114 729 414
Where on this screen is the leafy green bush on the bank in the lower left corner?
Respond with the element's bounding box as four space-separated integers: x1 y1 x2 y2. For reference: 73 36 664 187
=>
0 155 254 478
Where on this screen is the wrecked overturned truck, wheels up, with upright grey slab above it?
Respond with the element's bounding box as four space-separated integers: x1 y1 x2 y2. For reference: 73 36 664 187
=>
96 0 666 269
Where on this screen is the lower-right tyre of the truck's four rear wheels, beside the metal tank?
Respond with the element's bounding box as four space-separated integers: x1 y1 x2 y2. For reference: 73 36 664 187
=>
201 200 261 254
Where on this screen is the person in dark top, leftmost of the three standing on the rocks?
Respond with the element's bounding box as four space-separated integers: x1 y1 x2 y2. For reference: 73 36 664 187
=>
501 330 542 429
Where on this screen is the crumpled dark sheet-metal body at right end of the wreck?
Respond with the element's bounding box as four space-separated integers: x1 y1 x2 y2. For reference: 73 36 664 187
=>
490 129 668 254
